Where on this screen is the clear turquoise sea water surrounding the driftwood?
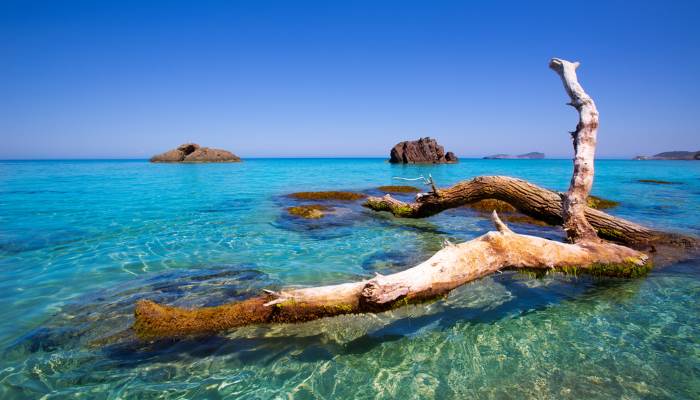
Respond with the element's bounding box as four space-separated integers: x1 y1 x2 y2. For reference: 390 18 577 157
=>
0 159 700 399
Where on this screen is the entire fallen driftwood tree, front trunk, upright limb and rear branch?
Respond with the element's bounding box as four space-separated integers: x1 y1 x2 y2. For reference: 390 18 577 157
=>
134 59 684 339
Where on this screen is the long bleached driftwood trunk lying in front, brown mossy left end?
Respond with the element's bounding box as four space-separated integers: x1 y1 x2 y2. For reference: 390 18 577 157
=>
134 212 650 339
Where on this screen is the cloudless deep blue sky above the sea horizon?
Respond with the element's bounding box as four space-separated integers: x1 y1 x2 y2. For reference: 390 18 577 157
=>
0 0 700 158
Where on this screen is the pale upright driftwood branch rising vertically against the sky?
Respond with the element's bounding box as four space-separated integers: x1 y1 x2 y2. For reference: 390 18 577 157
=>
549 58 598 242
